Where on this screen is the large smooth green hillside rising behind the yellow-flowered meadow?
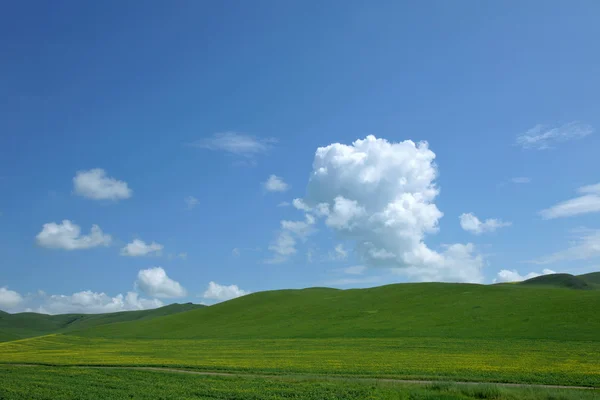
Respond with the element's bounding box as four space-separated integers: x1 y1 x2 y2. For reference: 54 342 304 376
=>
72 283 600 341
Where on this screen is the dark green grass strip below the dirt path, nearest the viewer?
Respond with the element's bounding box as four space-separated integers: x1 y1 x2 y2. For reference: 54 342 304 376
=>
0 366 600 400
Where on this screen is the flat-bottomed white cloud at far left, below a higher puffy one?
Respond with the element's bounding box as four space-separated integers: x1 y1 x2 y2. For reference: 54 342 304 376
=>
36 219 112 250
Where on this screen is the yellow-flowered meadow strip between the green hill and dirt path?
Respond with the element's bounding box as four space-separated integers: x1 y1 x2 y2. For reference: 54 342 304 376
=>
0 335 600 387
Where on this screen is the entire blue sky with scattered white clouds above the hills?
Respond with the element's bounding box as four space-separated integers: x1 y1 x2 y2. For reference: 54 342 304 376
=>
0 0 600 314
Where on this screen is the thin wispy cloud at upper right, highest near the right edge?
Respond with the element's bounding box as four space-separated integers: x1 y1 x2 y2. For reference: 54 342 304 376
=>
516 121 594 150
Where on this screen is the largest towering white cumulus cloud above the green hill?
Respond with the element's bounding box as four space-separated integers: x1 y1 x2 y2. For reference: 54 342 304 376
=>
297 136 483 282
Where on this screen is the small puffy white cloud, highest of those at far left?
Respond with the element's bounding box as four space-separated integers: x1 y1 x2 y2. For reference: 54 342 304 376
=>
73 168 133 200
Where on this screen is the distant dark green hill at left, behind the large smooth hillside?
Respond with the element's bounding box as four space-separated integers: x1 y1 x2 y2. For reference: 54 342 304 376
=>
0 303 204 341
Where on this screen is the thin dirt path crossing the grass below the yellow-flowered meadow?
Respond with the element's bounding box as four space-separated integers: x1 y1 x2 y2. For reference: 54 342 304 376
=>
0 364 598 390
